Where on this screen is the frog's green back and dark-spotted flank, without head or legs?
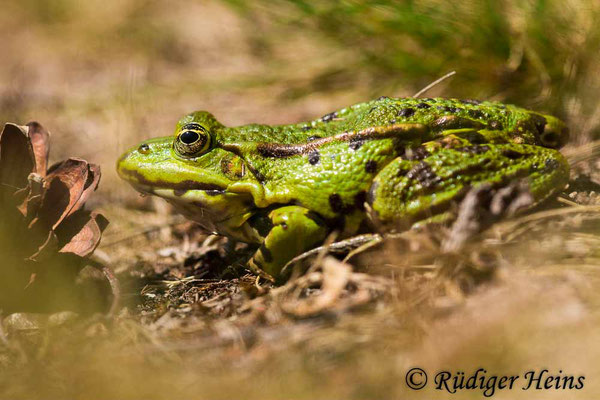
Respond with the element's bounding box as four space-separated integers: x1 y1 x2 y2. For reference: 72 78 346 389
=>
237 97 564 223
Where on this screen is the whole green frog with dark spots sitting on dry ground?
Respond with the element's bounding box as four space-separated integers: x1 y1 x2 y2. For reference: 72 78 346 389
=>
117 96 569 280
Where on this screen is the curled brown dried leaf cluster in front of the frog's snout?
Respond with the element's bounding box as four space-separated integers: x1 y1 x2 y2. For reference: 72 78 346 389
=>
0 122 114 310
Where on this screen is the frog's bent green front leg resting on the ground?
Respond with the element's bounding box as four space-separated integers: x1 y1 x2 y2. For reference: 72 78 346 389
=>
248 206 329 280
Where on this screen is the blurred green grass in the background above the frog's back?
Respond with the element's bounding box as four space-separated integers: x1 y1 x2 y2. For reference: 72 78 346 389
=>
227 0 600 139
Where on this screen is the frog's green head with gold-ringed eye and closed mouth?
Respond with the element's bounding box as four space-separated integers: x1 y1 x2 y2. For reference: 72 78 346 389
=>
117 112 260 238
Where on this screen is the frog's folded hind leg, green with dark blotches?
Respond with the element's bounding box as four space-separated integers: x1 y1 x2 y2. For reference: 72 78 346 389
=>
367 142 569 228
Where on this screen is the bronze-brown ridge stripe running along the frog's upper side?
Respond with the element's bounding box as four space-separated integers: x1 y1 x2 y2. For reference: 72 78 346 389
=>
229 124 428 158
